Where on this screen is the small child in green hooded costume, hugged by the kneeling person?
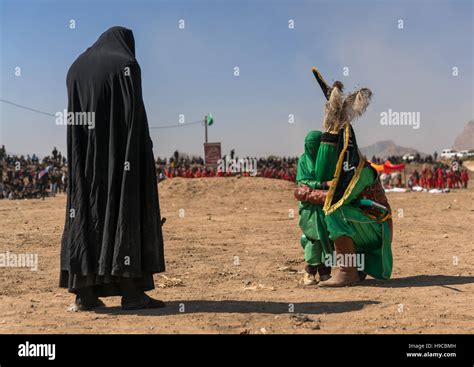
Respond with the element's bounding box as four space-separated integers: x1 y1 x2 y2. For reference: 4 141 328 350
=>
296 130 334 285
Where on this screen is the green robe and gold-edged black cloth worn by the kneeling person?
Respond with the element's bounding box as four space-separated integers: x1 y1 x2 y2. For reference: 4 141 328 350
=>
316 126 393 279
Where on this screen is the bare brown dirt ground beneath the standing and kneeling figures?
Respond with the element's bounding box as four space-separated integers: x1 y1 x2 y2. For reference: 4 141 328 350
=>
0 178 474 334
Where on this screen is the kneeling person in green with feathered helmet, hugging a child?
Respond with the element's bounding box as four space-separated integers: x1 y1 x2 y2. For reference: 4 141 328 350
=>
295 69 393 287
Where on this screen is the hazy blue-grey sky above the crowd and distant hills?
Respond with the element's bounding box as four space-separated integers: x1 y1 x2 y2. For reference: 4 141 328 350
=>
0 0 474 156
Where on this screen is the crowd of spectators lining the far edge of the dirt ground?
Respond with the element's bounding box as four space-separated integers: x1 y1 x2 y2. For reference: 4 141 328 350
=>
0 145 469 199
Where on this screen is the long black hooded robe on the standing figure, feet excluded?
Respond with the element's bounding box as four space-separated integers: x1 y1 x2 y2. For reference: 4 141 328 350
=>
60 27 165 296
